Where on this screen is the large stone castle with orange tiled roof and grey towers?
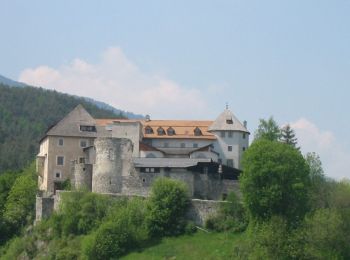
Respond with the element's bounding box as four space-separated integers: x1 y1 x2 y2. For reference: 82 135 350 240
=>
37 105 249 200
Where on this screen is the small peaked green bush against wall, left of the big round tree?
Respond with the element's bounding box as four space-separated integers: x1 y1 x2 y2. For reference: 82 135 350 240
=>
205 192 248 232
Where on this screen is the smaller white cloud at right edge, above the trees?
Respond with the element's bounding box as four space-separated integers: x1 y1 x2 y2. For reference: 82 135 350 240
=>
290 118 350 179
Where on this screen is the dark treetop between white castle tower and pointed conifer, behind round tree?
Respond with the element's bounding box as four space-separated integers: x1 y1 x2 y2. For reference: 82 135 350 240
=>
254 116 281 141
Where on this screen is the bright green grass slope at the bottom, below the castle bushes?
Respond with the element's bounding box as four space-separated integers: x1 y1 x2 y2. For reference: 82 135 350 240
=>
121 231 243 260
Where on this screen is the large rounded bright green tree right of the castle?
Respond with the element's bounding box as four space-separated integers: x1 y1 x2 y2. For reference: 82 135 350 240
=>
240 139 310 223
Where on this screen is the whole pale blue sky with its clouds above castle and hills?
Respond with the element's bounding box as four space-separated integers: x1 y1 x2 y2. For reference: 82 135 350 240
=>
0 0 350 178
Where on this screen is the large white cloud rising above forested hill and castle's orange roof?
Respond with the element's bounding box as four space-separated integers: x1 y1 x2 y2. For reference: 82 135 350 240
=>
19 47 207 118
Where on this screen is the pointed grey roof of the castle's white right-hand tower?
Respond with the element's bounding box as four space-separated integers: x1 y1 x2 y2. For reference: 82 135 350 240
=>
208 109 249 133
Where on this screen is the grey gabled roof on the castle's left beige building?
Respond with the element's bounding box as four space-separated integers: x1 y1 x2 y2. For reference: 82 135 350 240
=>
46 105 97 137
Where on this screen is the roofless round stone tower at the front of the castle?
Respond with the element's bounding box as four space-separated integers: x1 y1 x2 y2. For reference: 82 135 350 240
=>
92 137 133 193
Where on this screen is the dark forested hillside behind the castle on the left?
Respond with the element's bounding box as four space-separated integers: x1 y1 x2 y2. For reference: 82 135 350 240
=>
0 84 121 173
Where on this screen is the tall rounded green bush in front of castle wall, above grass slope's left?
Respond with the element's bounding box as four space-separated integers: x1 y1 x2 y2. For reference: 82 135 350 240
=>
146 178 189 236
